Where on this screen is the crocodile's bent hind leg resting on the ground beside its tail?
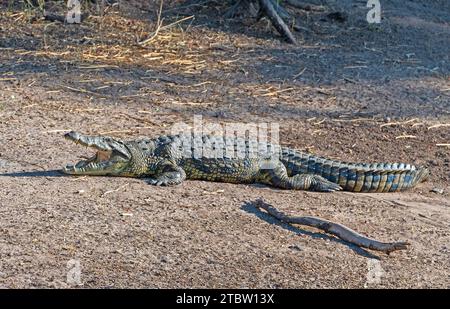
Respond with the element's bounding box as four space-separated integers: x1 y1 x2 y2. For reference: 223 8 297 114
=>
259 162 342 192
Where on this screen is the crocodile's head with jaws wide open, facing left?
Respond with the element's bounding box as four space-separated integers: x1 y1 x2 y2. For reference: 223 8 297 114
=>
62 131 133 176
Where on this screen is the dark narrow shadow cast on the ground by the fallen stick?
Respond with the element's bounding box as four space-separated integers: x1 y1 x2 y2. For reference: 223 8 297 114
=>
241 202 380 260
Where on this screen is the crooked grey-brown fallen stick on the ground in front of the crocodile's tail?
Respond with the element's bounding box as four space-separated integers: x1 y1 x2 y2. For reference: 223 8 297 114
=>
255 199 409 254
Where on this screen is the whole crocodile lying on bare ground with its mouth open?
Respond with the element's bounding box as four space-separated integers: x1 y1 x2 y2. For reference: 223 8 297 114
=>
62 131 429 192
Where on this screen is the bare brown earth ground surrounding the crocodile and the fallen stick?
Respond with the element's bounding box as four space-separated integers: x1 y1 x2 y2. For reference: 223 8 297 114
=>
0 0 450 288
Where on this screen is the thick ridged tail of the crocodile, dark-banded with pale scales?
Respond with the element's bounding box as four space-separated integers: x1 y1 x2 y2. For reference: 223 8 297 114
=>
282 149 429 192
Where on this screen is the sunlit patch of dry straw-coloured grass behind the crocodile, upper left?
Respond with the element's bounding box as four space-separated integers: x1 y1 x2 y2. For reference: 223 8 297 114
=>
0 5 243 74
